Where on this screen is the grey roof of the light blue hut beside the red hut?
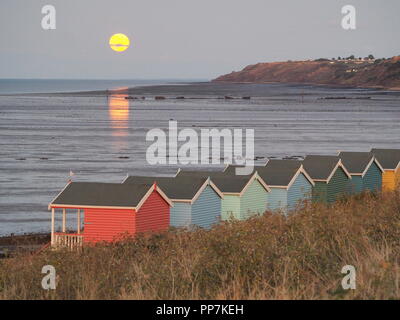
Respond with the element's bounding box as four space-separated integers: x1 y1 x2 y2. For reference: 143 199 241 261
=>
124 176 208 200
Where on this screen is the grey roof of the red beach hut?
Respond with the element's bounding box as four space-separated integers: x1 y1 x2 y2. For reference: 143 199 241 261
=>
51 182 152 208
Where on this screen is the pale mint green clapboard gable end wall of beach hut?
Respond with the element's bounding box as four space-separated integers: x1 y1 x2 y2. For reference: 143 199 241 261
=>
240 179 268 220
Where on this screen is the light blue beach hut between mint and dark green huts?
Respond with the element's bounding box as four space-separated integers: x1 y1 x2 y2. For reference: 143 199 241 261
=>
224 159 314 213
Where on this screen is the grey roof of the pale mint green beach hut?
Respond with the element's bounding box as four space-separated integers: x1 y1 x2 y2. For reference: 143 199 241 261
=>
177 170 250 193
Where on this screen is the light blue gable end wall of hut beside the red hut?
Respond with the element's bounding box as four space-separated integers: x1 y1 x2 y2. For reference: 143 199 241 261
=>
192 185 221 229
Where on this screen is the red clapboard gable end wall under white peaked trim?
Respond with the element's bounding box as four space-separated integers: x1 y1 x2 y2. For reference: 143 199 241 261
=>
136 190 170 233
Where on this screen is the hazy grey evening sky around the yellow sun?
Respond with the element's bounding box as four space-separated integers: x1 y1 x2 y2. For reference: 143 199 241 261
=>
0 0 400 79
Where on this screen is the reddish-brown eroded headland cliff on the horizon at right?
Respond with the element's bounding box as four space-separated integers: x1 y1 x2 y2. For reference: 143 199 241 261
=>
213 56 400 90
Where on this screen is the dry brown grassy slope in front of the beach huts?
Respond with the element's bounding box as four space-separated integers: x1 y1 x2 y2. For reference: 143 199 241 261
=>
0 192 400 299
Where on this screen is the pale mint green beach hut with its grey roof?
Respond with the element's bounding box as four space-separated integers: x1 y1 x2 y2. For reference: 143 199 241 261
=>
176 170 270 221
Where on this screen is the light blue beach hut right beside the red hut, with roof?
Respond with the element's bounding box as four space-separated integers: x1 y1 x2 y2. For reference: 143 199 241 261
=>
123 176 223 229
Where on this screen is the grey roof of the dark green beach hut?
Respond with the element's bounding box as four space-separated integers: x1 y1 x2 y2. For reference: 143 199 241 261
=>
302 155 340 180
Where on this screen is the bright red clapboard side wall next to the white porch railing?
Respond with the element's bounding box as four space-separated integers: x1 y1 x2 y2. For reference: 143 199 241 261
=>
83 208 135 243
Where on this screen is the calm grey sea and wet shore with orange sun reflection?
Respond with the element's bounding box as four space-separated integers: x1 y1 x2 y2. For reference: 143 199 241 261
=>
0 81 400 235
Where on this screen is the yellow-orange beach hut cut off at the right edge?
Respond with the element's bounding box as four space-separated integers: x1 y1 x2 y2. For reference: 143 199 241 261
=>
371 149 400 191
